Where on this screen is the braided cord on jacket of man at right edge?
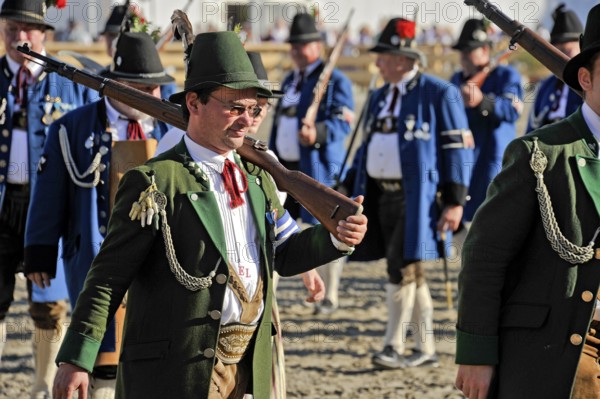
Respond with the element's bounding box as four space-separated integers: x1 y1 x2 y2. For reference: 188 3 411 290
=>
529 137 600 265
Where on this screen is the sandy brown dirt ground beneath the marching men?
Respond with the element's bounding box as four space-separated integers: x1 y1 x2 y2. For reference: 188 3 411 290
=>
0 252 462 399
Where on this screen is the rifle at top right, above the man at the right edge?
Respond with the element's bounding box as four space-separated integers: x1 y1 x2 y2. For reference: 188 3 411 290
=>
465 0 582 95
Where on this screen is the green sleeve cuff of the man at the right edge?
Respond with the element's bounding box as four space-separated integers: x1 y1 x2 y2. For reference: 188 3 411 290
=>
456 328 499 365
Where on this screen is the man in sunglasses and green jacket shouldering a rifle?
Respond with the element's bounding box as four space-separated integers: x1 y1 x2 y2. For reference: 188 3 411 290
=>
53 32 367 399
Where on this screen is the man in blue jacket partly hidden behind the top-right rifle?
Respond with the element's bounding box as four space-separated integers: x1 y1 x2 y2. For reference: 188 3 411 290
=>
527 4 583 132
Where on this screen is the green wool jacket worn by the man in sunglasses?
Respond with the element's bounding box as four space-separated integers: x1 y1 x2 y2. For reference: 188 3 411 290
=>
57 141 344 399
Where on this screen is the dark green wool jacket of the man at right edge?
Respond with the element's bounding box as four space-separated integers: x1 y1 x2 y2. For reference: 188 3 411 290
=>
456 109 600 399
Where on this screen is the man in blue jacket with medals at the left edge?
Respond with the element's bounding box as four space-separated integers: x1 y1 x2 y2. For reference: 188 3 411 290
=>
0 0 95 397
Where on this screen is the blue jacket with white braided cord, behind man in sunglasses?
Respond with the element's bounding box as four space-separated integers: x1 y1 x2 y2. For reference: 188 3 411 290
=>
25 99 167 351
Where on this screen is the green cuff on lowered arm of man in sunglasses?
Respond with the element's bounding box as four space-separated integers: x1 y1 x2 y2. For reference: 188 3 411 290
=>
56 329 100 373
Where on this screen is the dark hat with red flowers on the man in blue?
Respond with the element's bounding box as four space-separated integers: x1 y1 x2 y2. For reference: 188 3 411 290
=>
369 17 427 66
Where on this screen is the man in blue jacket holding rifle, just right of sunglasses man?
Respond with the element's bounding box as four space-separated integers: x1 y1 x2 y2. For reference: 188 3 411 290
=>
269 14 354 313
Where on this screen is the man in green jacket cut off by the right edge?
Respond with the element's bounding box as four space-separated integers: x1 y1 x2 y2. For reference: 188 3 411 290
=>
456 5 600 399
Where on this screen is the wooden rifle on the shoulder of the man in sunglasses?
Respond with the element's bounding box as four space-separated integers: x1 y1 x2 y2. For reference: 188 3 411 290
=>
17 45 362 237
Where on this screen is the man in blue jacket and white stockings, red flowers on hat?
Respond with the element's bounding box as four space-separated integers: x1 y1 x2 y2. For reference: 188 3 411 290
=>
344 18 473 369
